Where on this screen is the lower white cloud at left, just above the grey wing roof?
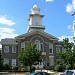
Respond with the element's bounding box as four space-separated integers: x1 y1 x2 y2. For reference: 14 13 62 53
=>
0 28 18 40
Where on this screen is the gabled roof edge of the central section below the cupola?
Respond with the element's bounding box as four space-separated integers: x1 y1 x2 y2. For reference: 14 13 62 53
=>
15 31 59 40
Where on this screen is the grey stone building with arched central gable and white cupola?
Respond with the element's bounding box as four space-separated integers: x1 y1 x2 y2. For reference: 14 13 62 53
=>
1 5 61 68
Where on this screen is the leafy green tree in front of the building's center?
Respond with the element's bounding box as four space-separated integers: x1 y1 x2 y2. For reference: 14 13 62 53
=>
18 44 41 72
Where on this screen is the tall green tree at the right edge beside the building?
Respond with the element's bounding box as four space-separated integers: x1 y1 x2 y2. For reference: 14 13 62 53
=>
57 38 75 69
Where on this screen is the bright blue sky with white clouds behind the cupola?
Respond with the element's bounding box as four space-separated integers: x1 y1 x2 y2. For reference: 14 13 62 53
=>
0 0 75 47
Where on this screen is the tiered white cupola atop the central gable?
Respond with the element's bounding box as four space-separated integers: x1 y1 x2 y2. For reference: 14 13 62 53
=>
27 4 45 32
